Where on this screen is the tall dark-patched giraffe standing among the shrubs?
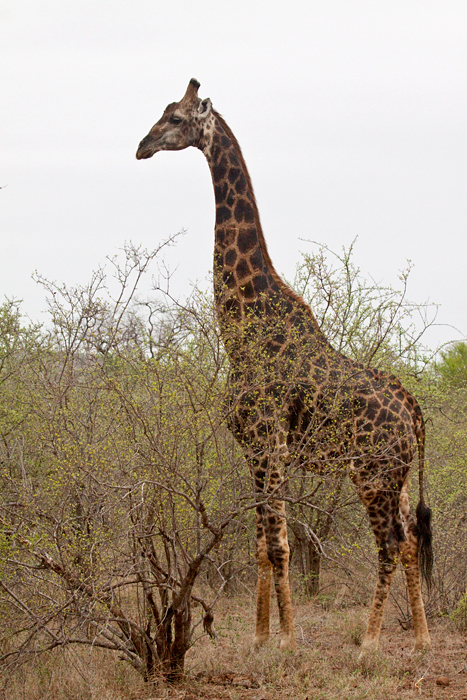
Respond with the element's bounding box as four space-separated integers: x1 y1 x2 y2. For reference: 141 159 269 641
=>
136 79 432 654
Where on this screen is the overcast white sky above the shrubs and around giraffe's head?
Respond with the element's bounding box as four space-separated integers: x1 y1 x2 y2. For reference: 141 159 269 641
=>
0 0 467 344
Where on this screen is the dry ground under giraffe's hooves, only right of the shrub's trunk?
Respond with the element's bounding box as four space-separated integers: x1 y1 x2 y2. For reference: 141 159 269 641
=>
156 601 467 700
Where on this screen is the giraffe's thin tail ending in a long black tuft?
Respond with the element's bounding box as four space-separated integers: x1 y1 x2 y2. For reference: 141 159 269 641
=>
416 412 433 590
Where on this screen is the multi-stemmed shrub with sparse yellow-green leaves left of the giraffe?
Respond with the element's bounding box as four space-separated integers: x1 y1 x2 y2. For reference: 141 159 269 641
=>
0 241 254 681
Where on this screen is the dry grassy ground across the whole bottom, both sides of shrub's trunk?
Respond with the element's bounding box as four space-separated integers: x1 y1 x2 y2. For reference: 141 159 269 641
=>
1 598 467 700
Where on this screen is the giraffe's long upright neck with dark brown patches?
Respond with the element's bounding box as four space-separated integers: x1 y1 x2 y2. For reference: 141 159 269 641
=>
199 111 322 358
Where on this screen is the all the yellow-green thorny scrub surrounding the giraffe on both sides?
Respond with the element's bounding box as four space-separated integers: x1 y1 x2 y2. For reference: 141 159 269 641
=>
0 237 467 696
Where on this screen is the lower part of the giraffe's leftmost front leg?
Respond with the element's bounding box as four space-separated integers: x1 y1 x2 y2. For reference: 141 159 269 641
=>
254 506 272 647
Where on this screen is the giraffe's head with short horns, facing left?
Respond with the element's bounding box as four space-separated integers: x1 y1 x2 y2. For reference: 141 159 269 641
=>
136 78 212 160
